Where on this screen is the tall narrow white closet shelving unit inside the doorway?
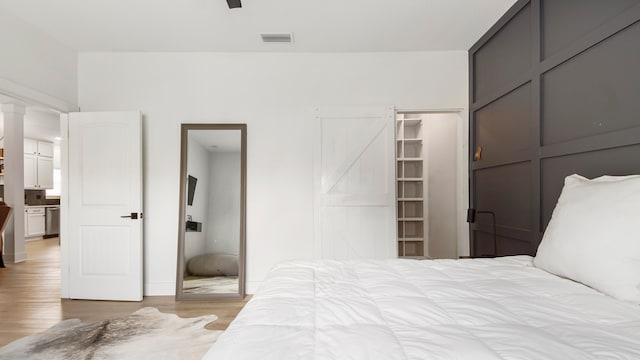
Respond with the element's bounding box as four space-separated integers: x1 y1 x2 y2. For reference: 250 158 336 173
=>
396 114 425 258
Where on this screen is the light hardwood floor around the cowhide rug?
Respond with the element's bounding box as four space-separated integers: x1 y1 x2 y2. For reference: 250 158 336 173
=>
0 238 248 346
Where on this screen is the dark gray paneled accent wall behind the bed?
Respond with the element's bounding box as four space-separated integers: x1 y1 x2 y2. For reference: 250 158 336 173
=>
469 0 640 255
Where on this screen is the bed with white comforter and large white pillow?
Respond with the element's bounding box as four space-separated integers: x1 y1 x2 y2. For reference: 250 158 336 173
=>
205 175 640 360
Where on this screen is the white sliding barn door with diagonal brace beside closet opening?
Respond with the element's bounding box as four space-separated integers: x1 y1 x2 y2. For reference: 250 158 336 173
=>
314 106 397 260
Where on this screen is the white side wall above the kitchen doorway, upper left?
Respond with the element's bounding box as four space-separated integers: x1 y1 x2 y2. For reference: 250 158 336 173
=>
0 11 77 104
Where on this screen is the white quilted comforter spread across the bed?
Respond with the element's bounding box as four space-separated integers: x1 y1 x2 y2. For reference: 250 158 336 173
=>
205 256 640 360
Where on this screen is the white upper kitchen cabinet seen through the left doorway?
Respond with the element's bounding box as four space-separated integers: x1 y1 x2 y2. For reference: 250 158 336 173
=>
24 139 53 189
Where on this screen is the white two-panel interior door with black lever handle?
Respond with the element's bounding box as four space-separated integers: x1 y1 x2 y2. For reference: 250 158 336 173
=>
65 112 143 301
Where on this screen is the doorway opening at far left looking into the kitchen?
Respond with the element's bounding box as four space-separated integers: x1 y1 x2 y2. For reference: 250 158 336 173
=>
0 99 62 290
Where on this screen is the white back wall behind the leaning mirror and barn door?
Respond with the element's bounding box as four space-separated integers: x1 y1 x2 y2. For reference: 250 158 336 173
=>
78 51 468 295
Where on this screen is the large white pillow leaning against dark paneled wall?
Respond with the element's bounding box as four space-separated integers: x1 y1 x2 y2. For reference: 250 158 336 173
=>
534 175 640 304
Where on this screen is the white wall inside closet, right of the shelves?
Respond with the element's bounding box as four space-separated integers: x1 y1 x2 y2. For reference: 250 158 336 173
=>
422 113 460 259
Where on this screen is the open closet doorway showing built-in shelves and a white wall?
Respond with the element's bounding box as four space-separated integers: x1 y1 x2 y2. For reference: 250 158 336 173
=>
396 111 464 259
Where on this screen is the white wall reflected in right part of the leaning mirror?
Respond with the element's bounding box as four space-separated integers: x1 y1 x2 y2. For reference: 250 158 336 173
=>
207 151 242 254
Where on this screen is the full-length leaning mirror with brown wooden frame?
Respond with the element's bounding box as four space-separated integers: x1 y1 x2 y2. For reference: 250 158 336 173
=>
176 124 247 300
